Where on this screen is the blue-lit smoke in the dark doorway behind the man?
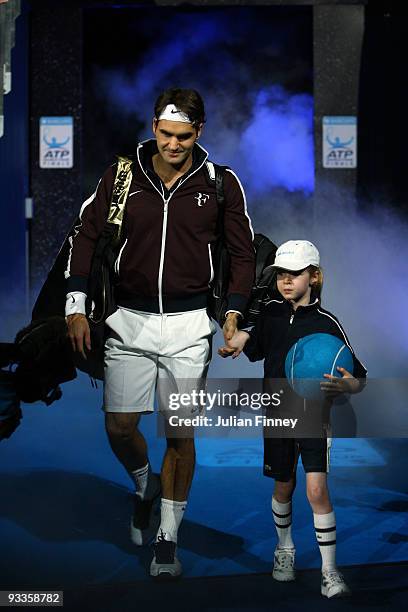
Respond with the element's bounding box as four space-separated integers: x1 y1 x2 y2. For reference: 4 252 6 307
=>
97 11 314 197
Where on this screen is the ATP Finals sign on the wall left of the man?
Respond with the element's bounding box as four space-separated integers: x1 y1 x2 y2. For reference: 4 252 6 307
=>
40 117 74 169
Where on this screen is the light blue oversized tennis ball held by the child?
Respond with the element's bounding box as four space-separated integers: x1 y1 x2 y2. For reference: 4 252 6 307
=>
285 334 354 400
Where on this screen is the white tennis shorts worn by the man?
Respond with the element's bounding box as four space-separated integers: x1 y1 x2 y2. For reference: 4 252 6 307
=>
104 308 217 416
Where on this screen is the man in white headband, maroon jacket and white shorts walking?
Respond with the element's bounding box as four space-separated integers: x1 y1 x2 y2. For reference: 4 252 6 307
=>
66 89 254 577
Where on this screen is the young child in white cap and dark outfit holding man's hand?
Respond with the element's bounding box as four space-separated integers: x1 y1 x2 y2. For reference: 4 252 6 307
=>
218 240 367 598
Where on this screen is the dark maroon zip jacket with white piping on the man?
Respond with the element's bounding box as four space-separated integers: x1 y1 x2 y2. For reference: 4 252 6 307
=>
66 140 255 312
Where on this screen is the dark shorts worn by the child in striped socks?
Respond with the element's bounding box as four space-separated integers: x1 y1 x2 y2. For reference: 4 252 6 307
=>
263 437 331 482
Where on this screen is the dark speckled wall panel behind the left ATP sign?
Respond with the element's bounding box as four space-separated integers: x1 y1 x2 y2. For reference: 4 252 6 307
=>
30 2 82 291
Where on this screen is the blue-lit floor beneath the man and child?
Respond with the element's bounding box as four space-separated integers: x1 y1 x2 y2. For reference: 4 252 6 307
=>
0 375 408 587
